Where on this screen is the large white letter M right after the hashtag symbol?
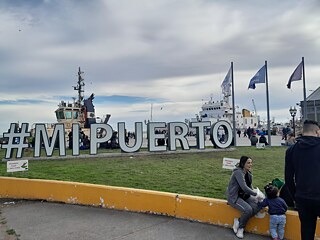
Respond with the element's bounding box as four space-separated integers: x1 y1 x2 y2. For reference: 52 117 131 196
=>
34 123 66 157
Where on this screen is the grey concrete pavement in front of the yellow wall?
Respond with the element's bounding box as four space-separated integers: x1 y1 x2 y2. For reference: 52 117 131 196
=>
0 199 270 240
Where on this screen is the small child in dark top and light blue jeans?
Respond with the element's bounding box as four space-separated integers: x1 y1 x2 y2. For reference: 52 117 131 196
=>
258 184 288 240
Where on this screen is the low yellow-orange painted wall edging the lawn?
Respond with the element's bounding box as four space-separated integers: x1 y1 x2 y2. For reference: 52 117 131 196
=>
0 177 320 239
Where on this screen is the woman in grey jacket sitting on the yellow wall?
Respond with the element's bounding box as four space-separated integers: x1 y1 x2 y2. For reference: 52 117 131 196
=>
227 156 260 238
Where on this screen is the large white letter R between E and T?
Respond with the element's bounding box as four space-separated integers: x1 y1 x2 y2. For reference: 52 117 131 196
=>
168 122 189 151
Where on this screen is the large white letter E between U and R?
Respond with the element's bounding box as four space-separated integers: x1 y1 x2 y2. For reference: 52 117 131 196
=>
147 122 167 152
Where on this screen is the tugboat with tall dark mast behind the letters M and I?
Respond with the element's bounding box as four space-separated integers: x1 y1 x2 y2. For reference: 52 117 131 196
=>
31 67 111 138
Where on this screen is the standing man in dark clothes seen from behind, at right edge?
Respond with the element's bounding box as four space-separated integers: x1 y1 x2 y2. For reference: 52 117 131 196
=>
285 120 320 240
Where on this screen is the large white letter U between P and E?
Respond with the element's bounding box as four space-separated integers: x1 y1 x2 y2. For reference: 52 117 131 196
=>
118 122 143 153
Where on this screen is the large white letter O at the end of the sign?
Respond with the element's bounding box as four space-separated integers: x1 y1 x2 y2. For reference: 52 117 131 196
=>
210 120 233 148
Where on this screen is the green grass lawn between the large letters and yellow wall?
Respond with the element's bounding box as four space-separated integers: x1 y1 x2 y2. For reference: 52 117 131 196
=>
0 147 286 199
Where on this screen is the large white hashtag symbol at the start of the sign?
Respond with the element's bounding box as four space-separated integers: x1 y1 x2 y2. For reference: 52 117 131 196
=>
2 123 30 159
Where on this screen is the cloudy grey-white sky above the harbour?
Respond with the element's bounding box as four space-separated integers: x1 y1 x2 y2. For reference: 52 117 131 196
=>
0 0 320 133
